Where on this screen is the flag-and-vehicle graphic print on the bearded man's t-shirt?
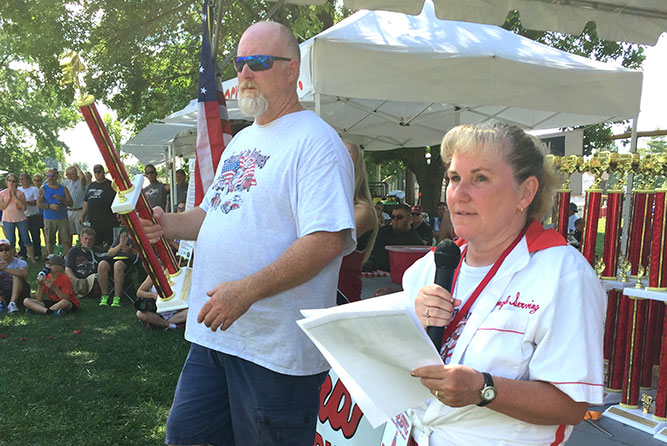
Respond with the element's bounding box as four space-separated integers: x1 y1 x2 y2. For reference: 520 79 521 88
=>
211 149 270 214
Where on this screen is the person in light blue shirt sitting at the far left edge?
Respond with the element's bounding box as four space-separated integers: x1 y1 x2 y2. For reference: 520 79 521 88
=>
0 238 30 314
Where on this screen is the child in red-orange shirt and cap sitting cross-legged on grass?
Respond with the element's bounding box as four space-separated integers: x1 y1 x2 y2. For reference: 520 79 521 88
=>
23 254 79 316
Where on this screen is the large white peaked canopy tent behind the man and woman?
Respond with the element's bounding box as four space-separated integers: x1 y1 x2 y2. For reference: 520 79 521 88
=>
153 2 642 150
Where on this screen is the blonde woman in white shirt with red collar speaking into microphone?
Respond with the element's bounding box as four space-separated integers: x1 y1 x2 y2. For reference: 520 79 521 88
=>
403 123 606 446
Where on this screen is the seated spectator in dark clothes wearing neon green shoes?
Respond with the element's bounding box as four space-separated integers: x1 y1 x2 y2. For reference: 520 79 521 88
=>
97 228 141 307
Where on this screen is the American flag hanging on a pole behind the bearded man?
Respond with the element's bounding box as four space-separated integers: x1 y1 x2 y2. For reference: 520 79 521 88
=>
195 0 232 206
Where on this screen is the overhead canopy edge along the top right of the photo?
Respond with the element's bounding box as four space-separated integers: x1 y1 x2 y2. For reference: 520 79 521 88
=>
272 0 667 45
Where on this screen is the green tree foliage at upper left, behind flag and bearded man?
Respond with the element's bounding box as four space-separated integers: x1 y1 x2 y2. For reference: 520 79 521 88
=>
0 0 348 174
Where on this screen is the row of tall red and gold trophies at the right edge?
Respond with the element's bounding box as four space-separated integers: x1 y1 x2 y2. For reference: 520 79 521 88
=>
549 152 667 421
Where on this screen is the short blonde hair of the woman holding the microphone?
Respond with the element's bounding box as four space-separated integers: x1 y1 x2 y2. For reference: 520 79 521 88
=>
440 121 559 221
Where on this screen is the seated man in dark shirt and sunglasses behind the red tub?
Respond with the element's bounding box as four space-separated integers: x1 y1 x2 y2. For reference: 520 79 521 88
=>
364 203 424 271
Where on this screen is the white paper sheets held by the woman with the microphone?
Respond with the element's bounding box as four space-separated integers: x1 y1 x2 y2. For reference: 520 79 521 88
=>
297 293 443 427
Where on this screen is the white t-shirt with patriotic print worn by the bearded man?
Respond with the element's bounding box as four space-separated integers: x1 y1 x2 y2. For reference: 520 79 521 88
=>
185 111 356 375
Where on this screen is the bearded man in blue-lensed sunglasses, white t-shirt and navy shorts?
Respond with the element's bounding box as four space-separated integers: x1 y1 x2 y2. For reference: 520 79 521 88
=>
142 22 355 446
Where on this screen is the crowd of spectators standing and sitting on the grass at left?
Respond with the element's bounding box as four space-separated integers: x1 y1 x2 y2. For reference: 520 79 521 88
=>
0 164 188 328
